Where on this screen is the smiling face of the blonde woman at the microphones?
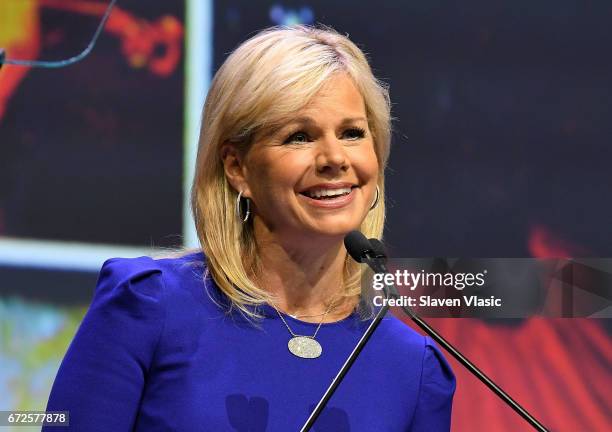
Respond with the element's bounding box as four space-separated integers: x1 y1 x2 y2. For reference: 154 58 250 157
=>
234 74 378 243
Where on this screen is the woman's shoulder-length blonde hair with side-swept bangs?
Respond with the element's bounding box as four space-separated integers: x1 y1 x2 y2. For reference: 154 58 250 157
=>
191 25 391 318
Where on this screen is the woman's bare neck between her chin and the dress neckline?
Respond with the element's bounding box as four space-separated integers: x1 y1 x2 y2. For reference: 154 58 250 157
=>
255 221 356 322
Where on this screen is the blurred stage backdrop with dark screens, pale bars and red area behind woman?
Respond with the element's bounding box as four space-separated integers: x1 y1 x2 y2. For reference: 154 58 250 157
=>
0 0 612 431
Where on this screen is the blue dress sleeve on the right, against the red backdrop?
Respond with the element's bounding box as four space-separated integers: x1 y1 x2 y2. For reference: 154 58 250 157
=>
410 336 456 432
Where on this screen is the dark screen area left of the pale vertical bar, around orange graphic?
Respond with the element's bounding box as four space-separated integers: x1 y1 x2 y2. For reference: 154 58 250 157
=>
0 0 184 246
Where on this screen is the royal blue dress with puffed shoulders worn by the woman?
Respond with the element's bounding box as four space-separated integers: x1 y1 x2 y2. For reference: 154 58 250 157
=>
43 253 455 432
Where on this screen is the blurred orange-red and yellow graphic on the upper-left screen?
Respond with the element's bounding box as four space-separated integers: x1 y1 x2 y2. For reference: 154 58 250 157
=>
0 0 184 120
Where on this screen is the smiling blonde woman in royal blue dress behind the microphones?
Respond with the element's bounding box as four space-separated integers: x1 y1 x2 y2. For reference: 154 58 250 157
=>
47 26 455 432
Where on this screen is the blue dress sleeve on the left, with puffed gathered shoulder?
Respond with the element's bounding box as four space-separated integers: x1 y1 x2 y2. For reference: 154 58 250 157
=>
42 257 165 432
